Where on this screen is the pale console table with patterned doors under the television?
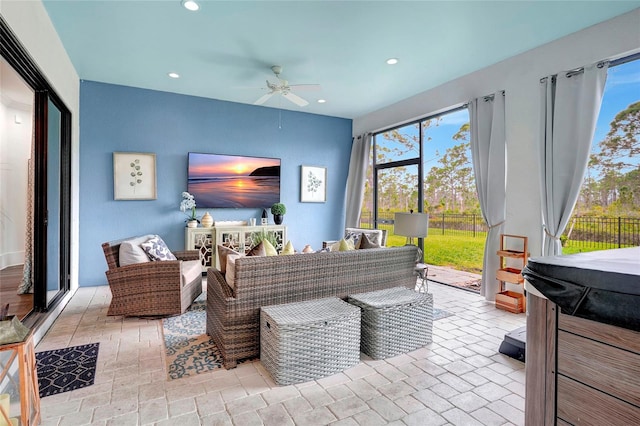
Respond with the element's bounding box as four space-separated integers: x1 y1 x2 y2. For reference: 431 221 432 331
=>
184 225 287 272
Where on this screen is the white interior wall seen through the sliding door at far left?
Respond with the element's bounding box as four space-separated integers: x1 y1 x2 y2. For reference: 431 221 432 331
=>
0 96 33 269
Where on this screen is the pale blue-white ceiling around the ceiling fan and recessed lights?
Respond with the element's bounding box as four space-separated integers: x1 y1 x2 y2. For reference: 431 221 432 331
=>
36 0 640 118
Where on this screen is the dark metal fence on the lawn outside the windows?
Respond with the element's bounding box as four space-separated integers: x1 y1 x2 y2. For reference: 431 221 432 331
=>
360 212 640 249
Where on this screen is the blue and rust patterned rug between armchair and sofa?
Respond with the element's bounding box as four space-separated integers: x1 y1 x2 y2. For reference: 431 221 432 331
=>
162 293 222 380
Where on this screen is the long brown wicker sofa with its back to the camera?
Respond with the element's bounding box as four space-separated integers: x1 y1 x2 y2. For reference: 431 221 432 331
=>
207 246 417 368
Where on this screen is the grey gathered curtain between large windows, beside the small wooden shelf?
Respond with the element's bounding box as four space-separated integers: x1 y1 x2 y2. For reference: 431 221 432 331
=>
469 92 507 300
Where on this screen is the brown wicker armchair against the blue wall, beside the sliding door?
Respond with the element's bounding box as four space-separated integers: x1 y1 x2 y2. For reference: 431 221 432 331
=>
102 236 202 316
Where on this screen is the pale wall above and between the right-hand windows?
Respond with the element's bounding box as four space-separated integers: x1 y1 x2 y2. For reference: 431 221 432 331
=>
353 8 640 256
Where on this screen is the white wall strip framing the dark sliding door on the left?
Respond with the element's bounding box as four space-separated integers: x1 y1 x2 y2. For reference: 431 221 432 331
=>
0 0 80 342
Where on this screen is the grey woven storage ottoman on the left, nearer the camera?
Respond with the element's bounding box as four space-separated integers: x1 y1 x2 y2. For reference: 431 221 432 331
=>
260 298 360 385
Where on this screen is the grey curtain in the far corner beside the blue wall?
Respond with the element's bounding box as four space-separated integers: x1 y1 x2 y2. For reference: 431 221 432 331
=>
345 133 371 228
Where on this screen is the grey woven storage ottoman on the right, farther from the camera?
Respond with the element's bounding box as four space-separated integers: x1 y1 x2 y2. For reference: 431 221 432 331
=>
347 287 433 359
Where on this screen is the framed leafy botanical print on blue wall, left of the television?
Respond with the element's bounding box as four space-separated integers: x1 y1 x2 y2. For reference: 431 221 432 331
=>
113 152 157 200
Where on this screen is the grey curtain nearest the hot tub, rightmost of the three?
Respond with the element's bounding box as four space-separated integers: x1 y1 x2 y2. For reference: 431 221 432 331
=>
540 64 607 256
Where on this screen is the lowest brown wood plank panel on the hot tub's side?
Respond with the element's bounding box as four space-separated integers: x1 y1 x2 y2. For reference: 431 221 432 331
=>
556 375 640 426
